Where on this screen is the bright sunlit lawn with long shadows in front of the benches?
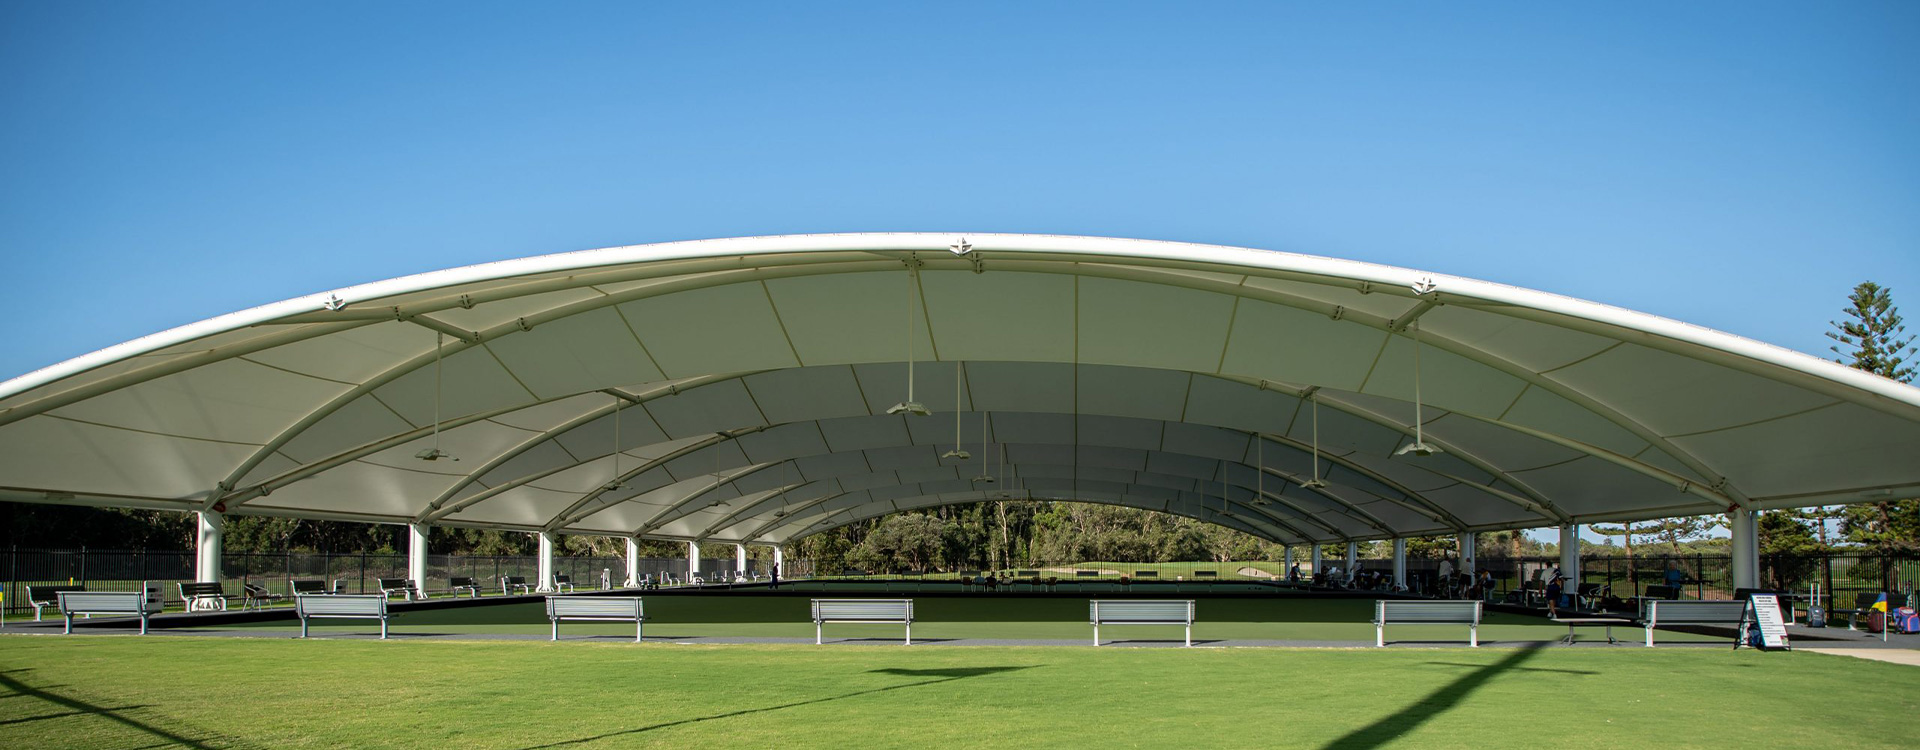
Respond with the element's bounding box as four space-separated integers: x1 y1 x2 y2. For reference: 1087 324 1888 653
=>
0 635 1920 750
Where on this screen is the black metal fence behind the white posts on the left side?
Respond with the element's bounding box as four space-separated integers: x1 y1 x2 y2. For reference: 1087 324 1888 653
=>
0 549 804 616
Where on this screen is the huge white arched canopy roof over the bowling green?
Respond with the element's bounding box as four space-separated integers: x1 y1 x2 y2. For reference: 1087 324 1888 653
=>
0 234 1920 543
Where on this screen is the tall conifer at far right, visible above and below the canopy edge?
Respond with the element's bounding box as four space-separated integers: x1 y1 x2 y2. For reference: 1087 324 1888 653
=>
1826 282 1920 587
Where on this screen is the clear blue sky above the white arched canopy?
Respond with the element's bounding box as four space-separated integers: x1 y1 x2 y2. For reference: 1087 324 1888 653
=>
0 0 1920 387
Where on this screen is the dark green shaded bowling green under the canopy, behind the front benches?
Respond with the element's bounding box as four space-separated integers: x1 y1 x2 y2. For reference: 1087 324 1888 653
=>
206 595 1730 643
